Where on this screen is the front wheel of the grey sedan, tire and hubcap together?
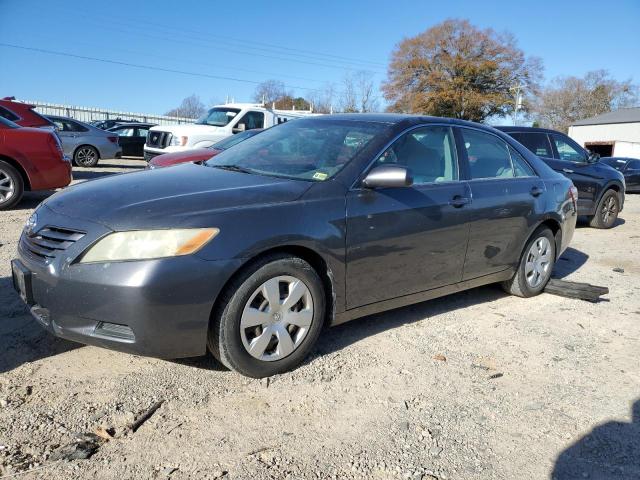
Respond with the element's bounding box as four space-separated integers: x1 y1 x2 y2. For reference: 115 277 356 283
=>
208 254 325 378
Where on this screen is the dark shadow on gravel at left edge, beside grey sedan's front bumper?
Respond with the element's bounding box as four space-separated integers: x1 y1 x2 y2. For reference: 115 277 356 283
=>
0 277 81 374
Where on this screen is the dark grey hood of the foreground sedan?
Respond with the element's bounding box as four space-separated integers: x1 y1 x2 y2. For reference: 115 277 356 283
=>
44 163 312 230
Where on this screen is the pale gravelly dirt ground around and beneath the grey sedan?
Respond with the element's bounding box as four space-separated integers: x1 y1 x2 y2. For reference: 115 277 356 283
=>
0 160 640 480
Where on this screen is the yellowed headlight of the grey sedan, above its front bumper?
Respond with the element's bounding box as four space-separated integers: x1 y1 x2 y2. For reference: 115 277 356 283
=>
80 228 220 263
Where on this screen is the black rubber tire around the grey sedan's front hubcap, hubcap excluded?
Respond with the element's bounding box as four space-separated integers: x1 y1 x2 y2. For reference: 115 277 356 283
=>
207 254 326 378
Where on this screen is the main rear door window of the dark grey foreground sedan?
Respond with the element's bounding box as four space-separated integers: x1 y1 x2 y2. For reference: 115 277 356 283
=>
460 128 514 180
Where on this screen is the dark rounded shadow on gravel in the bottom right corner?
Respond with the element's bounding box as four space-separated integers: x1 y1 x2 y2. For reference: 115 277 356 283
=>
551 399 640 480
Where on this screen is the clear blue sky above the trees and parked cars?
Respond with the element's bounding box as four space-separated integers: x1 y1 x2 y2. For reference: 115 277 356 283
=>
0 0 640 113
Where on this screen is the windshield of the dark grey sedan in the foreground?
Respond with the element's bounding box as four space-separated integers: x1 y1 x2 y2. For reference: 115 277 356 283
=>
205 119 385 181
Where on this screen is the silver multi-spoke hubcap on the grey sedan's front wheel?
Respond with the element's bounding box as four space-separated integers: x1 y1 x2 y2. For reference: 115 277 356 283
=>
240 275 313 362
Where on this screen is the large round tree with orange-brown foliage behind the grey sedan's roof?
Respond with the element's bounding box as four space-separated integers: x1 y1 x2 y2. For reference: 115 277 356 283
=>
382 19 542 121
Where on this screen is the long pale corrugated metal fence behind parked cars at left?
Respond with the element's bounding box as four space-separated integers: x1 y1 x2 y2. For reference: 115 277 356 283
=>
20 100 195 125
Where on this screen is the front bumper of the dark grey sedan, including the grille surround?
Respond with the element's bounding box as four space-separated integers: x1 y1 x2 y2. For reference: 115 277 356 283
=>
18 207 241 358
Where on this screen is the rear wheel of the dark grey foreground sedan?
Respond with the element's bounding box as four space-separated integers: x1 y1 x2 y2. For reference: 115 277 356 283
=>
502 227 556 297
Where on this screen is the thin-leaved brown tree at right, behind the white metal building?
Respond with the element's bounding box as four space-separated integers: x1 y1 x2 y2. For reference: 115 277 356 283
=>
532 70 638 132
